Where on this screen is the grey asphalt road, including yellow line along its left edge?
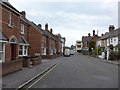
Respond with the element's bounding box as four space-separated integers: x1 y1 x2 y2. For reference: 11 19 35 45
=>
26 54 118 88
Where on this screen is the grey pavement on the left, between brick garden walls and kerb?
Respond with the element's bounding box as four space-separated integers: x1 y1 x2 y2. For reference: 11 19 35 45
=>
2 57 62 88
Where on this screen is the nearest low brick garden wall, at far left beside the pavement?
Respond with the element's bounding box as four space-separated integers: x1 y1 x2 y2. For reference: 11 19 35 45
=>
2 60 22 75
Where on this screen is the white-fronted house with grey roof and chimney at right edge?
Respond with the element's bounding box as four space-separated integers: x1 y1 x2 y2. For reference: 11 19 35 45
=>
98 25 120 60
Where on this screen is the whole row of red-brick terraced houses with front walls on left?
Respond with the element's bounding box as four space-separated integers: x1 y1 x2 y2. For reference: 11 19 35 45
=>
0 1 65 75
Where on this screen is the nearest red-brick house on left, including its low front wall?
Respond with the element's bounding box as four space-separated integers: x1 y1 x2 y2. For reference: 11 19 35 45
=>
0 2 29 74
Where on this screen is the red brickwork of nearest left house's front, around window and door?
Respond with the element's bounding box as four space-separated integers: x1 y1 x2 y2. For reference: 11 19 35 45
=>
0 6 20 61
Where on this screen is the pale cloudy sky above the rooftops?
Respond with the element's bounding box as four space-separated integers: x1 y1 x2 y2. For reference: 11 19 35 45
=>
9 0 118 46
